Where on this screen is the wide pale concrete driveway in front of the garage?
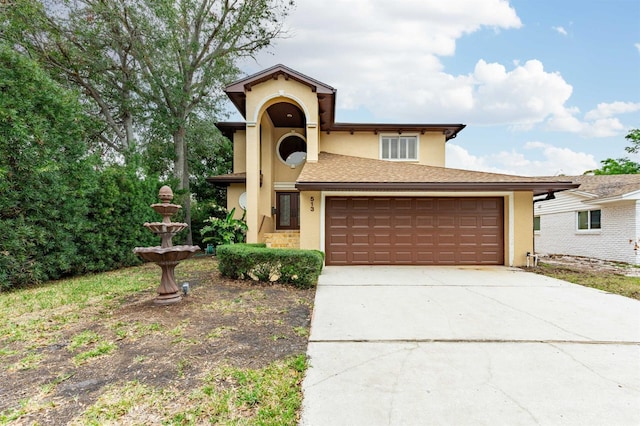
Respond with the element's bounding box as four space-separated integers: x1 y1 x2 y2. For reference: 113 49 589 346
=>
301 266 640 426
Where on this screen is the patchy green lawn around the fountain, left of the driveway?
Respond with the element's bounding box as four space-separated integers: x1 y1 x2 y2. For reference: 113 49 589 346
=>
0 259 312 425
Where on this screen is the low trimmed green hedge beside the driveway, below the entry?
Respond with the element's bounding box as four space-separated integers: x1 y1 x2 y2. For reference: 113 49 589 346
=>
216 244 324 288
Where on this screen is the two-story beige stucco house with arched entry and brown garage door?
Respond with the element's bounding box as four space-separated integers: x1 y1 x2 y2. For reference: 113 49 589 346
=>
209 65 575 265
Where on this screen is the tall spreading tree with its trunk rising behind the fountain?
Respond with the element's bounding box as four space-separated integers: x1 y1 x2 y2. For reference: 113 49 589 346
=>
1 0 293 243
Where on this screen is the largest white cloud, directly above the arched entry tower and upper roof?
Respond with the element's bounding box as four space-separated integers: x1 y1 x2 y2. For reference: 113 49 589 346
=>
248 0 522 121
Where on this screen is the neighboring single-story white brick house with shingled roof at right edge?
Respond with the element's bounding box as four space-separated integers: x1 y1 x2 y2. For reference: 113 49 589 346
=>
534 175 640 264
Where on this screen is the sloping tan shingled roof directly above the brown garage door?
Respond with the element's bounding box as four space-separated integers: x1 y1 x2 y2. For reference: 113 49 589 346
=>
296 152 577 195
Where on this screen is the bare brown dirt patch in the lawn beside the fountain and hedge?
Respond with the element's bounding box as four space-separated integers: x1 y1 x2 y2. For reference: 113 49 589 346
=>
0 257 315 425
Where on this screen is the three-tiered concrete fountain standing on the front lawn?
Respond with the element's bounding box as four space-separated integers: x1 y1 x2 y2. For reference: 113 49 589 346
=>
133 186 200 305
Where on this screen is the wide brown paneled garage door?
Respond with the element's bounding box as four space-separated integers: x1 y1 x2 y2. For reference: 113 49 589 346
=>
325 197 504 265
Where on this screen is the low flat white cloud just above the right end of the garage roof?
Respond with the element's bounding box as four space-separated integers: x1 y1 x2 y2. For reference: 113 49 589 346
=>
446 142 599 176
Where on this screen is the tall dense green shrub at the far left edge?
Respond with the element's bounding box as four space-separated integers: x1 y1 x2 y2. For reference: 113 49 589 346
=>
0 44 95 291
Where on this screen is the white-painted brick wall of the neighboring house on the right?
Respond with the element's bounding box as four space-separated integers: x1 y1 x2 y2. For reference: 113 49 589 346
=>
535 202 640 263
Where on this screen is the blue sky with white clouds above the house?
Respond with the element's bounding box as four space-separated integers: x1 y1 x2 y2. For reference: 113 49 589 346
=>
235 0 640 175
